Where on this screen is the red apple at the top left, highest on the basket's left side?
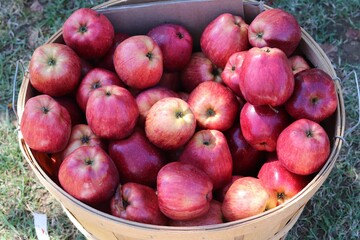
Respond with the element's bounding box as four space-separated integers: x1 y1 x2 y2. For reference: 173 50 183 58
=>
62 8 115 59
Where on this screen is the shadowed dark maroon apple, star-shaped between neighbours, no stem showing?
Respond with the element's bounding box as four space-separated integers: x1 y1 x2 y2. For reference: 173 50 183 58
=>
108 129 166 187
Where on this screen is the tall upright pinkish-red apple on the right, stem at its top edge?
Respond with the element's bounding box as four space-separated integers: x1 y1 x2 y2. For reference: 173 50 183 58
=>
239 47 295 107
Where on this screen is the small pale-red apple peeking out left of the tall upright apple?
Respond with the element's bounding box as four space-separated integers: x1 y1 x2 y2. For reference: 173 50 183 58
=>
221 51 247 97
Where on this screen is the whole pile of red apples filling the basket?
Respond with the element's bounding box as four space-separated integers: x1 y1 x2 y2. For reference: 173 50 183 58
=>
20 8 337 226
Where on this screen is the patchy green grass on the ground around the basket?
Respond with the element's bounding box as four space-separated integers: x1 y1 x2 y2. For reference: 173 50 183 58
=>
0 0 360 240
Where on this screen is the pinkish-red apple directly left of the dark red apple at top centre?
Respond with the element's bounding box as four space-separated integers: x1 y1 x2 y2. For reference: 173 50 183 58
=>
114 35 163 89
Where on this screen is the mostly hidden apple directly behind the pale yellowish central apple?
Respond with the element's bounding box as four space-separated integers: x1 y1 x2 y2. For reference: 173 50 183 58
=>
135 87 178 125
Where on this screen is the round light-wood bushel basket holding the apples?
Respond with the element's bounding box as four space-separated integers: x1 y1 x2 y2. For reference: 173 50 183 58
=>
17 0 345 240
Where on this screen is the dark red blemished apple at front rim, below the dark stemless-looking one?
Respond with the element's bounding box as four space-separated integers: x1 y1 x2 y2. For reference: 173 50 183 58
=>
110 182 167 226
